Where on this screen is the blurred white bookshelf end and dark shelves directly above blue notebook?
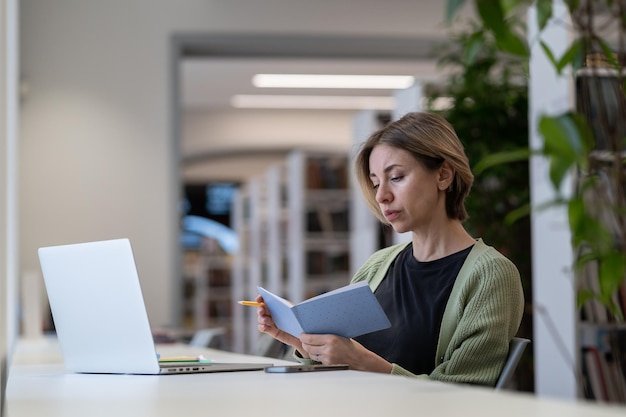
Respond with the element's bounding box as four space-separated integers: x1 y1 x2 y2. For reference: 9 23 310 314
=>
286 150 350 302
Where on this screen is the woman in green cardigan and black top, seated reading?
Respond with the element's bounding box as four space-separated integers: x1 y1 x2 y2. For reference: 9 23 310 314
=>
257 113 524 386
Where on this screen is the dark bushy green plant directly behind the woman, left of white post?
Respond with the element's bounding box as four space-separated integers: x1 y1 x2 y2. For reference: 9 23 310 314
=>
426 23 533 391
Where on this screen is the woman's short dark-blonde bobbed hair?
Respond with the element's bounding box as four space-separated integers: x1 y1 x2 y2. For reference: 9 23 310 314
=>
354 112 474 223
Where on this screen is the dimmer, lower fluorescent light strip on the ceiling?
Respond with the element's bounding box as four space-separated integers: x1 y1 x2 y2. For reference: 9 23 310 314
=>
231 95 395 110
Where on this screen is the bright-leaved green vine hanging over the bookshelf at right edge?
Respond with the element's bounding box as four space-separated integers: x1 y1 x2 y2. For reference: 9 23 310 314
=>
446 0 626 321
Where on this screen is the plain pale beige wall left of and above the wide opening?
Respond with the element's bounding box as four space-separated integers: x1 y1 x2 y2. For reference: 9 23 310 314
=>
20 0 456 326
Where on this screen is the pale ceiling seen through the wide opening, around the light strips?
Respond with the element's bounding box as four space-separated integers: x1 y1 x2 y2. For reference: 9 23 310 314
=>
173 32 456 182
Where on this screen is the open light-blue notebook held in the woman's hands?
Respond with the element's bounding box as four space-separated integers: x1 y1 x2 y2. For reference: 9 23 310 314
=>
258 282 391 337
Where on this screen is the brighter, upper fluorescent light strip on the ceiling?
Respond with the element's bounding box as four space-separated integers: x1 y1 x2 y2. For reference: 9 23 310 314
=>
252 74 415 90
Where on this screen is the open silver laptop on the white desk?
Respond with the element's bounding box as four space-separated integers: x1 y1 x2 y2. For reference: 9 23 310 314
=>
39 239 272 374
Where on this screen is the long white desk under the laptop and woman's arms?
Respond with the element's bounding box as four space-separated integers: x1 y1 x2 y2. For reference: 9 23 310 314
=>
5 340 626 417
